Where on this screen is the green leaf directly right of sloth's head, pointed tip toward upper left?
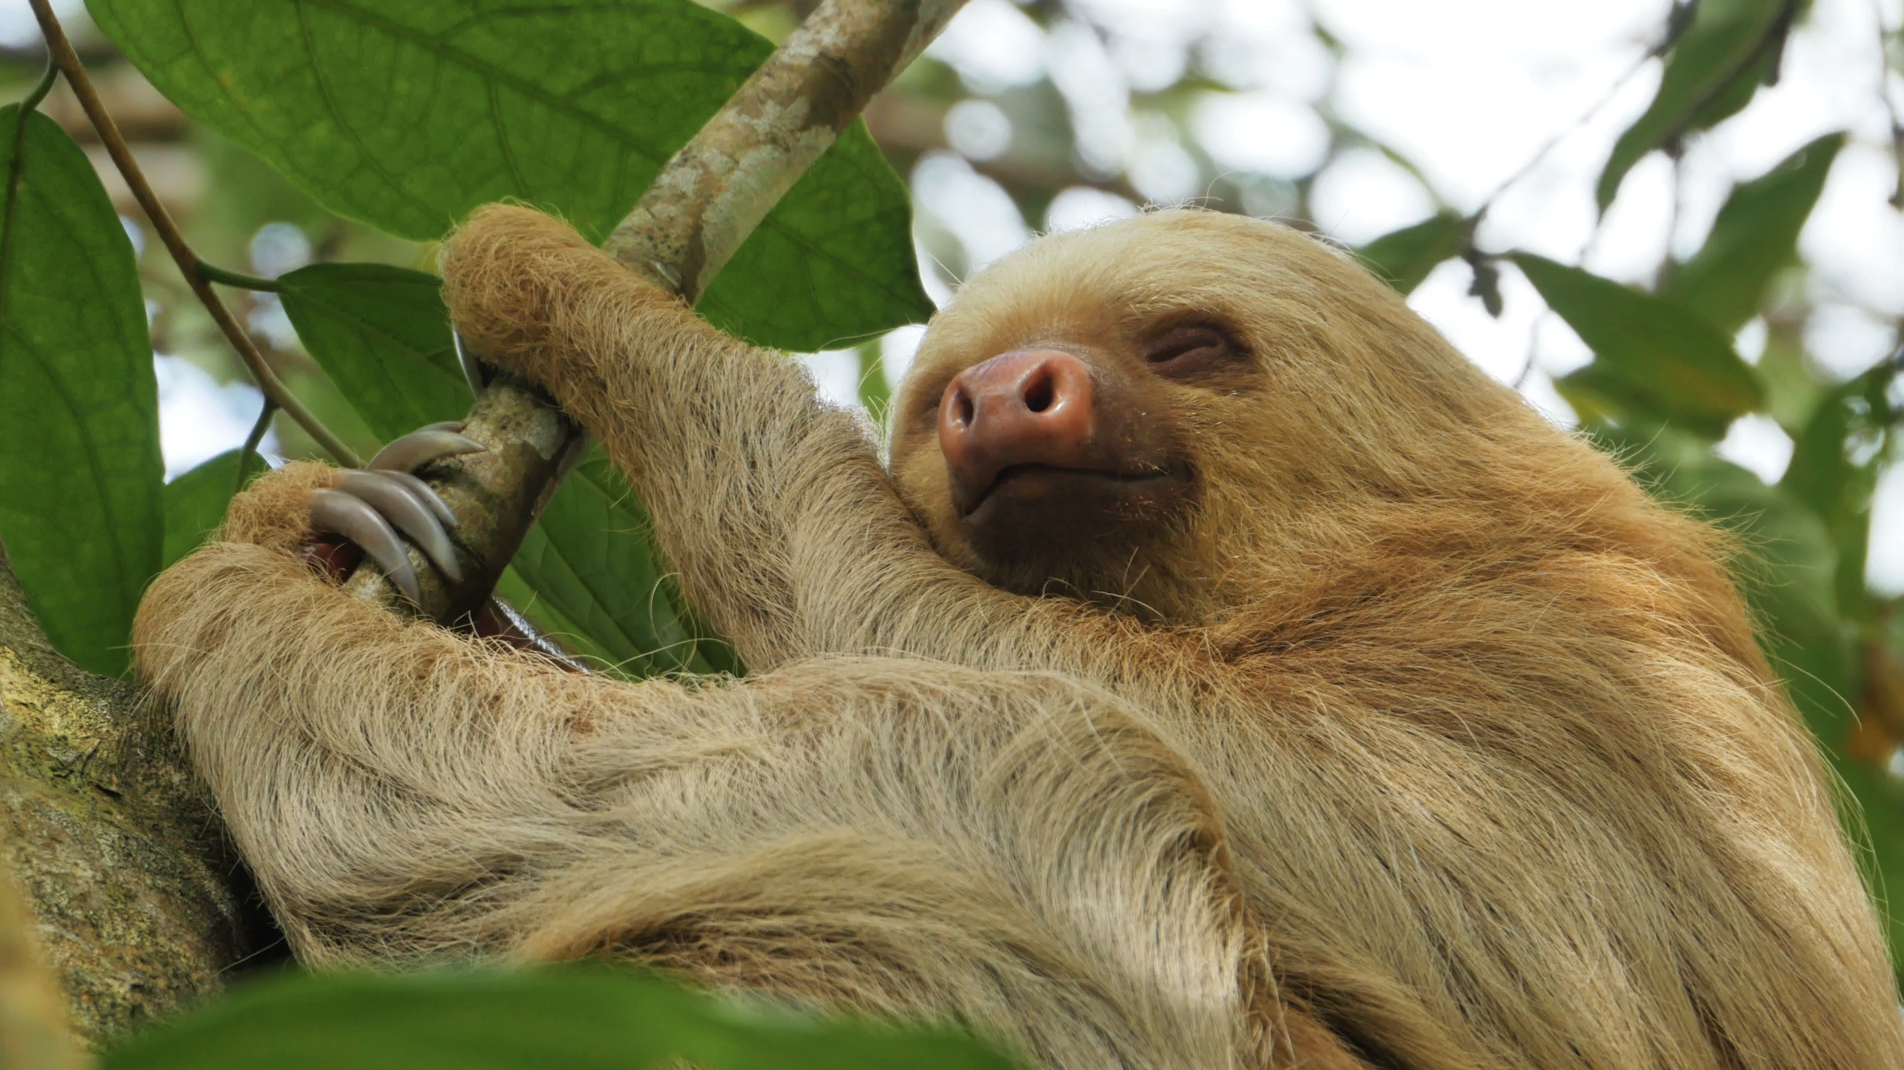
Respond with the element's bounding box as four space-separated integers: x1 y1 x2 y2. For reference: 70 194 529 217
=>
1510 253 1763 436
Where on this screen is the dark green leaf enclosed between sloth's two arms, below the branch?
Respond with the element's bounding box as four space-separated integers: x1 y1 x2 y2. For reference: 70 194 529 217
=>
510 446 724 678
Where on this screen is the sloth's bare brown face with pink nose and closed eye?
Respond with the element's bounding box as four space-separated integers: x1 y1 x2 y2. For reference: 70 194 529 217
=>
893 308 1257 598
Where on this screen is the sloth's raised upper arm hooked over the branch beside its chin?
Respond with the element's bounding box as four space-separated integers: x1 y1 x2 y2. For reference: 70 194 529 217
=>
444 208 1167 680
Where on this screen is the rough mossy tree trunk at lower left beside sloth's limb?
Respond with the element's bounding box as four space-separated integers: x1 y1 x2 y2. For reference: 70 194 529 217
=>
0 554 253 1047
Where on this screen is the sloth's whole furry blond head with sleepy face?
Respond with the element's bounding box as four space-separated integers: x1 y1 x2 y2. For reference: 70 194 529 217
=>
893 209 1559 617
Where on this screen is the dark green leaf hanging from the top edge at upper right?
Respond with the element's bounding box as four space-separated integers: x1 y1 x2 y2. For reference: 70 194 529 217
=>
1594 0 1795 211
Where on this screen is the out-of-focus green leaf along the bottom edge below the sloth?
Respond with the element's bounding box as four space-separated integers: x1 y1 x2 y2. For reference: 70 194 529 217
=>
103 967 1011 1070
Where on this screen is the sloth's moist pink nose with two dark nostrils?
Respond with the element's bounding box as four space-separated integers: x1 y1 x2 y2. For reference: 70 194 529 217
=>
939 348 1097 497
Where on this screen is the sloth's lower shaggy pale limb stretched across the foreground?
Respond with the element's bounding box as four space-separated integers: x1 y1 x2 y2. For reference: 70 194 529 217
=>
135 485 1274 1066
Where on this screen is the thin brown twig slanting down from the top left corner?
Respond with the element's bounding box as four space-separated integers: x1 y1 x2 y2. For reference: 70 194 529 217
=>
29 0 364 468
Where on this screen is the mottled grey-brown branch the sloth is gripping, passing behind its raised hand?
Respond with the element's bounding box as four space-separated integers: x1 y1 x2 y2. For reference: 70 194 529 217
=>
357 0 965 624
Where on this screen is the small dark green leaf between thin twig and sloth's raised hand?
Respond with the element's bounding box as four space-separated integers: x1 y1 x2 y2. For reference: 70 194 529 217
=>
278 265 470 442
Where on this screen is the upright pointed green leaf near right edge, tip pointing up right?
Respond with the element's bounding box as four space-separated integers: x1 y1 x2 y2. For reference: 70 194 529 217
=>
1660 133 1845 333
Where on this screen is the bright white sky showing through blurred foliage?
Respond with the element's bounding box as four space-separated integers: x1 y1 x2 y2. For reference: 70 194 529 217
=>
0 0 1904 592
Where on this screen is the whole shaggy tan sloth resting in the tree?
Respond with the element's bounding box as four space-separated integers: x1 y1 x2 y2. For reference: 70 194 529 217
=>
135 206 1904 1070
